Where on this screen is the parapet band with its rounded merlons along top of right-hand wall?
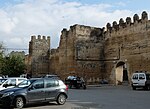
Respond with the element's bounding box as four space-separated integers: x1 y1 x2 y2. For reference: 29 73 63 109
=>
106 11 150 37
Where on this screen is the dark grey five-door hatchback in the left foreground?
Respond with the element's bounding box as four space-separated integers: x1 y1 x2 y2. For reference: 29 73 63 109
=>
0 78 68 109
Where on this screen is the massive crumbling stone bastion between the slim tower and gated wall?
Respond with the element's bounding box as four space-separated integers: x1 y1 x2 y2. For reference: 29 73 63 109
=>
50 25 103 82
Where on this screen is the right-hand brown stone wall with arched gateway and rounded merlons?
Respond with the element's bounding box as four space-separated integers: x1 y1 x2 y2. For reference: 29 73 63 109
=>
104 12 150 84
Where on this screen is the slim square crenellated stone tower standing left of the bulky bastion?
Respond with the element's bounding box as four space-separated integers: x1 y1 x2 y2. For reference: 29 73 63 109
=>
28 35 50 77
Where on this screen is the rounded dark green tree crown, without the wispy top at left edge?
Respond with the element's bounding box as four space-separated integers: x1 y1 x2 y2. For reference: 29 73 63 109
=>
1 55 26 77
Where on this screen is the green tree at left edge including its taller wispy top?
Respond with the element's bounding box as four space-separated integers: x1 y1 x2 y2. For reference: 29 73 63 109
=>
0 44 26 77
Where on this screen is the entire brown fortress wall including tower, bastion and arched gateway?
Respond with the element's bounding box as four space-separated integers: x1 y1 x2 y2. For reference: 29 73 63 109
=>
29 11 150 84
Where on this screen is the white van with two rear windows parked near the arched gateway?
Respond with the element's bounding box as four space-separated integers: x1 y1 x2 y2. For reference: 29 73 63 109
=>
131 72 150 90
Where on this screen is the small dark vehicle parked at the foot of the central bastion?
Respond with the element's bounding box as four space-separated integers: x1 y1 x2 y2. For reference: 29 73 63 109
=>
65 76 86 89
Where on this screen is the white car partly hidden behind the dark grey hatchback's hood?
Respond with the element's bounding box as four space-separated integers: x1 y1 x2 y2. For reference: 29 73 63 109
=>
0 77 27 90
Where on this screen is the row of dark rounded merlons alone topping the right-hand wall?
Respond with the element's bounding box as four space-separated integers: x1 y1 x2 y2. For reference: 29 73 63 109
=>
106 11 148 33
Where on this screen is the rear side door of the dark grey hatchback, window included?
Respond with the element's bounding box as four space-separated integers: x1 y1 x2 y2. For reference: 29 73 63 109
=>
45 79 59 100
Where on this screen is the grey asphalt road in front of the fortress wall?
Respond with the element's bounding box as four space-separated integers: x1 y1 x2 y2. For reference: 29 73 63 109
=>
1 85 150 109
